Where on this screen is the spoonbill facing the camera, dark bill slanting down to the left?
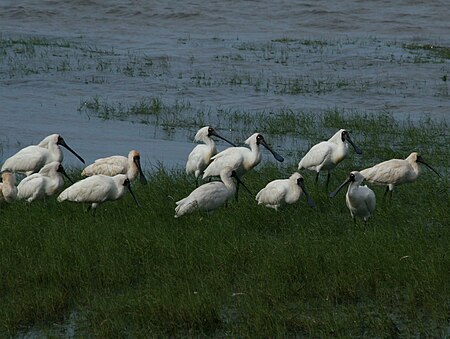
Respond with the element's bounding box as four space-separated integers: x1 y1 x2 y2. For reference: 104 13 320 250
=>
330 171 376 223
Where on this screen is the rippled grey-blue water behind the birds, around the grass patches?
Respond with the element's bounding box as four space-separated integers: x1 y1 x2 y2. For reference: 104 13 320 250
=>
0 0 450 168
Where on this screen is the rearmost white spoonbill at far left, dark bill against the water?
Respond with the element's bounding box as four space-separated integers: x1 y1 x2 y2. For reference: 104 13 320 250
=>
2 134 84 175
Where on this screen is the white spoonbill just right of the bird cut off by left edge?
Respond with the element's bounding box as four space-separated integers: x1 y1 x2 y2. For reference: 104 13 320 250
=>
17 161 73 202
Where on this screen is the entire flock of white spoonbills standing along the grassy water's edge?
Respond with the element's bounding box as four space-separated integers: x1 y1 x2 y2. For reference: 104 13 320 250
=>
0 126 439 222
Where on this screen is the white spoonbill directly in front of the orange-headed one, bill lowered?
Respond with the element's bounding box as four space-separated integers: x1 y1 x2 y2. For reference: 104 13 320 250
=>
57 174 140 212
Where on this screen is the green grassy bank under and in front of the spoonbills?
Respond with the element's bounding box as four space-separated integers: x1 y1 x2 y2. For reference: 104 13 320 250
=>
0 113 450 337
